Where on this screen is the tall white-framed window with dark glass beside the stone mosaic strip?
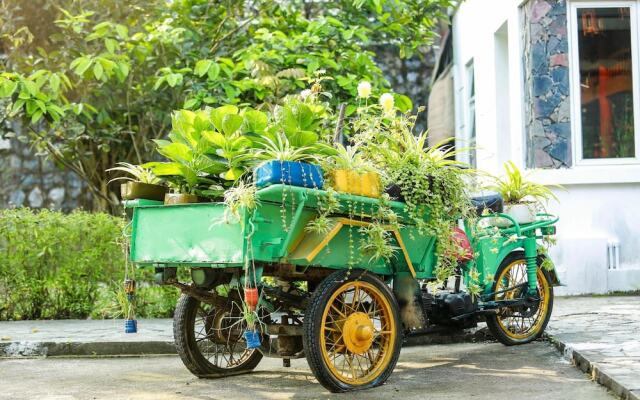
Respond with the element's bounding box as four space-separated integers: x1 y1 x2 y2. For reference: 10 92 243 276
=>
571 1 640 164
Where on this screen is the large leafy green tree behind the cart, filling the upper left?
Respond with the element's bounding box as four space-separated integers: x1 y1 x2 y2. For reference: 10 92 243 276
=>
0 0 453 210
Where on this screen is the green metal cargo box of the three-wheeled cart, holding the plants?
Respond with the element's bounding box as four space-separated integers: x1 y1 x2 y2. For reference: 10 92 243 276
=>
127 185 435 278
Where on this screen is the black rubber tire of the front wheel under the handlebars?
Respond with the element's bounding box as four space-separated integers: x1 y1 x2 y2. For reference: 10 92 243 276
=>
486 250 553 346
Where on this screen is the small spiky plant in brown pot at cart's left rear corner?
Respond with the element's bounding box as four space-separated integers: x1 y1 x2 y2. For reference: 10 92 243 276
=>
107 162 168 201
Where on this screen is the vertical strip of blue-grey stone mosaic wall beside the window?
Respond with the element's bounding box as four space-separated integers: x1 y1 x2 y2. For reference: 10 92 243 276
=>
522 0 572 168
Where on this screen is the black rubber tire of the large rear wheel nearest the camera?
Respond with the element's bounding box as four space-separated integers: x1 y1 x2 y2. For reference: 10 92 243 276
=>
302 270 402 393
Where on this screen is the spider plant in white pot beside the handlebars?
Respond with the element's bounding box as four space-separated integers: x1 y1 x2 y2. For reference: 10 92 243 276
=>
489 161 559 226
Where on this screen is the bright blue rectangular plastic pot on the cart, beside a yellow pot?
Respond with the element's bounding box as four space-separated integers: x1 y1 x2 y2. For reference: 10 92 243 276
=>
254 160 324 189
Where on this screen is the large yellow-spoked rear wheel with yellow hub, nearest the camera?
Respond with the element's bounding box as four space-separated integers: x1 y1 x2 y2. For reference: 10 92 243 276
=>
303 271 402 392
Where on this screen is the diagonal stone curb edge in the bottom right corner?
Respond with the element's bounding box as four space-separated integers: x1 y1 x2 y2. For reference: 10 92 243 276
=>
546 335 640 400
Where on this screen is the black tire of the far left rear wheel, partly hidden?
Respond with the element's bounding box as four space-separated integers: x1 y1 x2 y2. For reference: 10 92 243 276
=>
173 294 262 378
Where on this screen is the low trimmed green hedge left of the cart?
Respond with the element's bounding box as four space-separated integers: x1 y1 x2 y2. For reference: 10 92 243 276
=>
0 208 178 320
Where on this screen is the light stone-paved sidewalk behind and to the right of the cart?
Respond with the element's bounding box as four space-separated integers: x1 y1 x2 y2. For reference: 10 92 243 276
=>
0 296 640 400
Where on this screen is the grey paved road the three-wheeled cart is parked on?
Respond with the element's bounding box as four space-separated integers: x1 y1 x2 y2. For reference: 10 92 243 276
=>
0 342 614 400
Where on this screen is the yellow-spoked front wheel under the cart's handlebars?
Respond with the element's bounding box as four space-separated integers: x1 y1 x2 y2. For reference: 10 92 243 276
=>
487 251 553 346
